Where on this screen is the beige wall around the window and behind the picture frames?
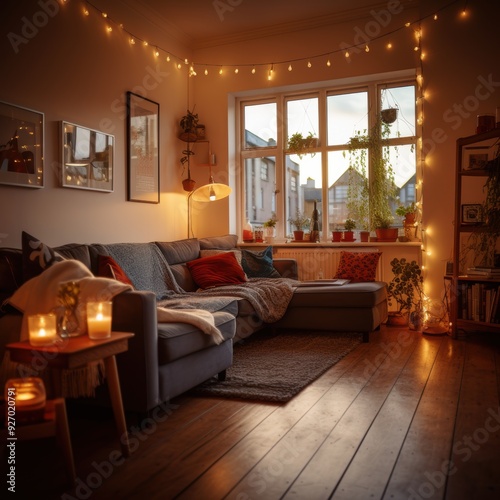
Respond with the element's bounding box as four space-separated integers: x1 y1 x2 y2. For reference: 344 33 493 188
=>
0 0 500 312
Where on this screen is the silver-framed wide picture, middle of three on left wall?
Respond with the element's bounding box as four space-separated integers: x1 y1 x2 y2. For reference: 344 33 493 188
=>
60 121 115 193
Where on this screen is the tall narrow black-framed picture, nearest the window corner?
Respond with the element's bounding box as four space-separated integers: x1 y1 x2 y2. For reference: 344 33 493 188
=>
127 91 160 203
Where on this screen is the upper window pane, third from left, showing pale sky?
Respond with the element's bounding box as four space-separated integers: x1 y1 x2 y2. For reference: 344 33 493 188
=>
327 92 368 146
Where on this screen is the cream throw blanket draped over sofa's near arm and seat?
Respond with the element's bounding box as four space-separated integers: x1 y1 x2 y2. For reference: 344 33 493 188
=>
1 260 224 397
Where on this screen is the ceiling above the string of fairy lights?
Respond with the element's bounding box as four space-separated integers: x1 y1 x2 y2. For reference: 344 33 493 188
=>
124 0 398 48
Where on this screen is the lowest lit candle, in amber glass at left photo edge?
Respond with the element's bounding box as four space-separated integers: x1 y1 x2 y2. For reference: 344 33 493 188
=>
5 377 46 424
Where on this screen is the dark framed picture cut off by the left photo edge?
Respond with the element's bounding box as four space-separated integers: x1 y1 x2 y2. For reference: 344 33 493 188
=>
0 101 45 188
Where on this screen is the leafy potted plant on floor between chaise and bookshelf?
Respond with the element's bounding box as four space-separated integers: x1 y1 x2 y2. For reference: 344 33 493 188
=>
387 258 424 329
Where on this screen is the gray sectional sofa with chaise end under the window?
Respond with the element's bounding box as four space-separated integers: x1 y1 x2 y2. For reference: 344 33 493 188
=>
0 235 387 413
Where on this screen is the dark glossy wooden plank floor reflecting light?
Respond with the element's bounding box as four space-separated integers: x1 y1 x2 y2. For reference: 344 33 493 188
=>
3 327 500 500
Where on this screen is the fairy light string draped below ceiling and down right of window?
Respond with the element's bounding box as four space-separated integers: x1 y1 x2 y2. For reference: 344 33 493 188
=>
60 0 469 330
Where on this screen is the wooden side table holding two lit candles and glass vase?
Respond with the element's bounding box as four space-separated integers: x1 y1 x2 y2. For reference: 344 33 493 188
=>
6 332 134 457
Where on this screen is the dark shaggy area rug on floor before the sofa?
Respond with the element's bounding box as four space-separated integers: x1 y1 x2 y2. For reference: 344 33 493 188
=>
191 330 362 403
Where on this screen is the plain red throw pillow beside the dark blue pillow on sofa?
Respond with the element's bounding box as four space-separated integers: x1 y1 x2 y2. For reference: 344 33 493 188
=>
186 252 247 288
